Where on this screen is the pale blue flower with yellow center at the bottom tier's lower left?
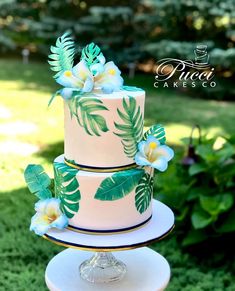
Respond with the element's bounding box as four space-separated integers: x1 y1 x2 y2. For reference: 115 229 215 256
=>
30 198 68 236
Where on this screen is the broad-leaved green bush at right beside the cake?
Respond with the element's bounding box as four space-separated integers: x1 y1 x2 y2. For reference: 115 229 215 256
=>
156 137 235 246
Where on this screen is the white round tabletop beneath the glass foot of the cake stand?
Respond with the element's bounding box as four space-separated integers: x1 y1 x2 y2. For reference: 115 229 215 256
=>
45 247 170 291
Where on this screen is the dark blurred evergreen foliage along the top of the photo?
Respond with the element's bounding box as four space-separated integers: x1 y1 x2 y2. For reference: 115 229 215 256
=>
0 0 235 99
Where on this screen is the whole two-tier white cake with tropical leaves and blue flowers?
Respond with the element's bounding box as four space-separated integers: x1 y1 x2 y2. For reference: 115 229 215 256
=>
25 33 173 235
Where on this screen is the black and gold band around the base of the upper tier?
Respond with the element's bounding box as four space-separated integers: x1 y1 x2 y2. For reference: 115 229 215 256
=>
64 157 137 173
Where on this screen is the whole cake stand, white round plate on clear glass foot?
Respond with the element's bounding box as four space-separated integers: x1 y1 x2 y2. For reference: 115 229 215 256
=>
44 200 174 284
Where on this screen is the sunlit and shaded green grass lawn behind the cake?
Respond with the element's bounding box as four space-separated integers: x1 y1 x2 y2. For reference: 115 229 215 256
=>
0 59 235 291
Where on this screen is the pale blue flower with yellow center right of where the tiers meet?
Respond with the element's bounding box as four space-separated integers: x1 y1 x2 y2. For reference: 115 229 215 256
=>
135 135 174 172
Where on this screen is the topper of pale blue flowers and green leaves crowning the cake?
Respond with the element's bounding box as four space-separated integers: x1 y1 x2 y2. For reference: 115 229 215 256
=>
48 32 123 99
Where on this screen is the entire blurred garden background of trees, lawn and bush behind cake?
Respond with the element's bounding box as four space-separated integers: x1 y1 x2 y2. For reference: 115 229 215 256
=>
0 0 235 291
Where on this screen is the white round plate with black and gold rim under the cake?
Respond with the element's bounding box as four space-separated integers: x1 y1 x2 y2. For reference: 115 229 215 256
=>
44 200 174 251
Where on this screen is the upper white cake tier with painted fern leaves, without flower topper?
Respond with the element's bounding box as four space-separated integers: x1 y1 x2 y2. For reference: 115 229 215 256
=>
64 87 145 171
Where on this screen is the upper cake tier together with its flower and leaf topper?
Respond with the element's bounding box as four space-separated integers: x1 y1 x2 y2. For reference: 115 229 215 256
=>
48 32 145 172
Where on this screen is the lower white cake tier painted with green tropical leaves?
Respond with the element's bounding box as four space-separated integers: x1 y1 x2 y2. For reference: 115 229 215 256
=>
54 155 153 233
